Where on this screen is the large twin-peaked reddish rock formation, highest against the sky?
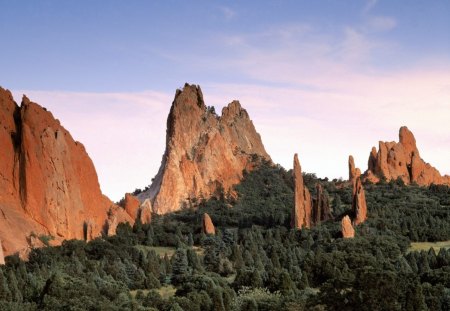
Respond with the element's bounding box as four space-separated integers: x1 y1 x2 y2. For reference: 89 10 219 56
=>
138 84 270 214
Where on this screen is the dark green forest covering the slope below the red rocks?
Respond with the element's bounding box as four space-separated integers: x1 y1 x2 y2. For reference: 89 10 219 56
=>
0 162 450 311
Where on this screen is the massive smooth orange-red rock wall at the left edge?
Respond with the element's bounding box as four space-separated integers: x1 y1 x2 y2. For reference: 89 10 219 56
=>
0 88 132 255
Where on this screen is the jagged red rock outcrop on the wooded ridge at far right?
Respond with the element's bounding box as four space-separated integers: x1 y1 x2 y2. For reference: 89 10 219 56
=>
364 126 450 186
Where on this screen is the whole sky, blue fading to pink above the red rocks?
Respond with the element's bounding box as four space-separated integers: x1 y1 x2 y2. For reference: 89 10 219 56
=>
0 0 450 200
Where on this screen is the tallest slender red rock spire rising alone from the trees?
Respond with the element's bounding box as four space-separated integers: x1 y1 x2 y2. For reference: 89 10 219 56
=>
291 154 312 229
